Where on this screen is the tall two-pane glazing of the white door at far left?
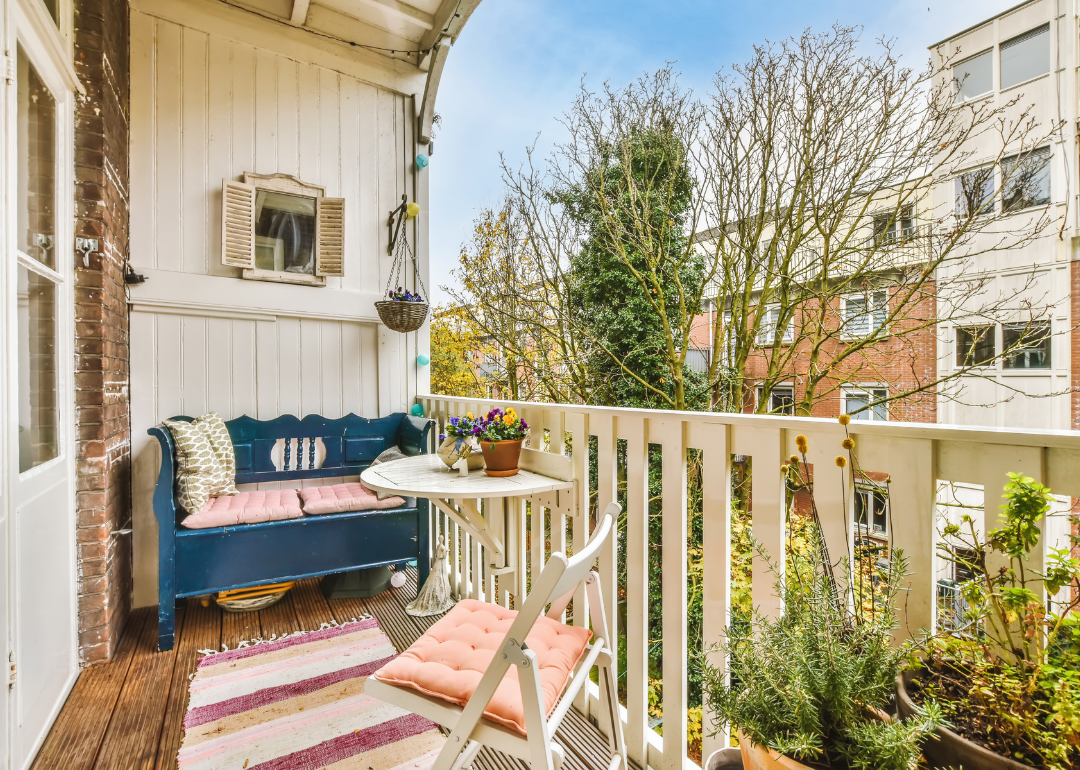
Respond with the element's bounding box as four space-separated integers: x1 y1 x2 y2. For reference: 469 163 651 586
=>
15 46 63 472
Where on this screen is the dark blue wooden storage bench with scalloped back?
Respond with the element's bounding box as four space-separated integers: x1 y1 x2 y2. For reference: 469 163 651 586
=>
148 414 432 650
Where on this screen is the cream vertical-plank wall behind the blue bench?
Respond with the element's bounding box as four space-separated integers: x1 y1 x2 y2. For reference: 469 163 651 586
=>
131 3 428 606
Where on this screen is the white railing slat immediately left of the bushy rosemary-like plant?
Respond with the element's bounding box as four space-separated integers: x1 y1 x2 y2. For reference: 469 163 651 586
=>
654 419 686 770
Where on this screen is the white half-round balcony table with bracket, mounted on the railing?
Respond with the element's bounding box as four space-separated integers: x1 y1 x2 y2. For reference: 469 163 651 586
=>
360 455 573 568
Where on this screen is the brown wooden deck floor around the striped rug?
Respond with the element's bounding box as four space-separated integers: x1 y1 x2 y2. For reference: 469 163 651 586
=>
32 570 607 770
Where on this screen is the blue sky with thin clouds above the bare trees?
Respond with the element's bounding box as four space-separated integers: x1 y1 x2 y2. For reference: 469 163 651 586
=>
426 0 1018 301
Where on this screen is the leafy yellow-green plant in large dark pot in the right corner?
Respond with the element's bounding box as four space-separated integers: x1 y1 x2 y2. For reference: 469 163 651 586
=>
896 473 1080 770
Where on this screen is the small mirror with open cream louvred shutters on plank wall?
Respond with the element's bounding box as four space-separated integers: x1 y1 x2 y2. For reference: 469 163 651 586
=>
221 174 345 286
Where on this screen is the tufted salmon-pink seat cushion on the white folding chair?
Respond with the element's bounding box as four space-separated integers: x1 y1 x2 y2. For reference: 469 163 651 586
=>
375 599 592 734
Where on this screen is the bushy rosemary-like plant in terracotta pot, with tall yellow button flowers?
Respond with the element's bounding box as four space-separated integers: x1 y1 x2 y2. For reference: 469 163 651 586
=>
702 416 940 770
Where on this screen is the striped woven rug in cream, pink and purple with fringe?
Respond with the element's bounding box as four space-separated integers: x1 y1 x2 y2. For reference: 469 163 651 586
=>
178 619 445 770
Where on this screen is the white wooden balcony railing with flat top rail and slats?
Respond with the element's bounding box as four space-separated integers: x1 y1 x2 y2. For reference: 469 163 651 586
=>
417 396 1080 770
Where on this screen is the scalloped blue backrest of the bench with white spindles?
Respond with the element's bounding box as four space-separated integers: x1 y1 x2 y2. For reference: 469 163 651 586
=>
147 413 432 524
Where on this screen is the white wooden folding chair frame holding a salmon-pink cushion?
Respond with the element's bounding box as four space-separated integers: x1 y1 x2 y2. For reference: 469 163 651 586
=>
365 503 627 770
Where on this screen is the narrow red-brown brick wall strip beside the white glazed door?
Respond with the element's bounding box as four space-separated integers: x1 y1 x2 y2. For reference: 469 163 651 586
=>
75 0 132 664
